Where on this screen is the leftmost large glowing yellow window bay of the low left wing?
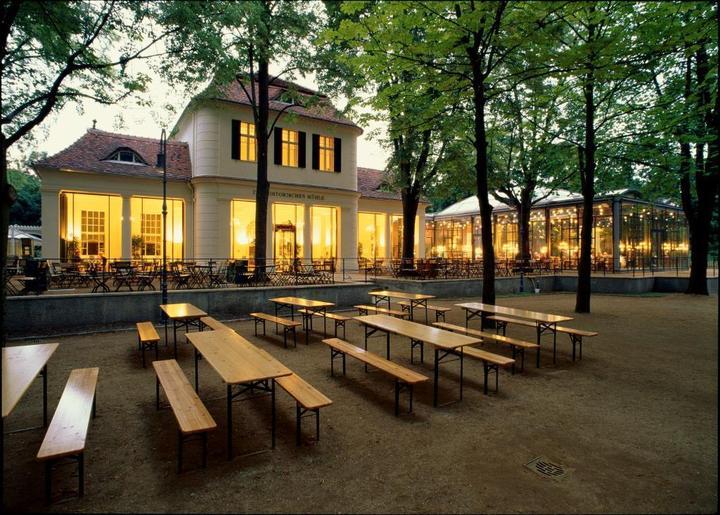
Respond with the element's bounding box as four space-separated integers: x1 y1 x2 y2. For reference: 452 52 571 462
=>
60 192 123 260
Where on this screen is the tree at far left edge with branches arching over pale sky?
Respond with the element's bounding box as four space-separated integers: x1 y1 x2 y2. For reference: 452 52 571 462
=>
0 0 172 346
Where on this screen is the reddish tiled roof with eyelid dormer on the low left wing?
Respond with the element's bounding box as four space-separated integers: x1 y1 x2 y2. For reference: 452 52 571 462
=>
34 129 192 180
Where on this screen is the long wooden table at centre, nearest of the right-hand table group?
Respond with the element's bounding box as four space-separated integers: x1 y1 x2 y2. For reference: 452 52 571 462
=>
354 315 482 406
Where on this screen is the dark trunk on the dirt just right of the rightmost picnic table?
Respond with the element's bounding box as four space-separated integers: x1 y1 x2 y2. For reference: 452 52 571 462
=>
575 70 595 313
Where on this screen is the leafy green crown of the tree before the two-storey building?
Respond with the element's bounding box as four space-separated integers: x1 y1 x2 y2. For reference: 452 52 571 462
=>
158 0 317 104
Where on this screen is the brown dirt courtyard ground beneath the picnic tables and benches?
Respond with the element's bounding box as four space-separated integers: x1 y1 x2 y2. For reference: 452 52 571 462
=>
4 288 718 513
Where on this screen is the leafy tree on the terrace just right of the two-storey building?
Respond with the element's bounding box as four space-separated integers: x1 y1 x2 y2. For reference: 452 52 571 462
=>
317 2 456 260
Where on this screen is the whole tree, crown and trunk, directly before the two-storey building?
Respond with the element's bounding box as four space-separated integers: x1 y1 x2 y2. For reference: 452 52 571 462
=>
161 0 317 264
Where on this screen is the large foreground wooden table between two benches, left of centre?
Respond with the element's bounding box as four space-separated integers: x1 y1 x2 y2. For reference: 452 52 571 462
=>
187 331 292 460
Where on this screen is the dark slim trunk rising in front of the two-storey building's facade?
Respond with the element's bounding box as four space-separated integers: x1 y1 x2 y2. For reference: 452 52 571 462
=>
258 58 270 266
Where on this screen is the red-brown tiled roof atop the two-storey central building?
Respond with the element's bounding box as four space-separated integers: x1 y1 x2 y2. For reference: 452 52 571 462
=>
215 79 362 130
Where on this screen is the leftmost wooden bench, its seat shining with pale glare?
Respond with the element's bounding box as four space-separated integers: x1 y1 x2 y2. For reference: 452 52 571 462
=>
37 367 100 502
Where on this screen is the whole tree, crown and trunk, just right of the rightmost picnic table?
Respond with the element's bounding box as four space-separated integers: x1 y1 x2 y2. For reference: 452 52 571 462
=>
548 2 653 313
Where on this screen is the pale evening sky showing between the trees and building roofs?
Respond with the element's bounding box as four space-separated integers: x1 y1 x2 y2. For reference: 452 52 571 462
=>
10 68 388 169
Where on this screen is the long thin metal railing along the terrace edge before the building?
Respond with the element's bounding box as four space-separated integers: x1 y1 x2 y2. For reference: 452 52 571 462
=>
3 256 718 296
